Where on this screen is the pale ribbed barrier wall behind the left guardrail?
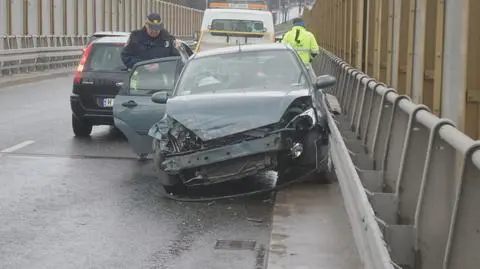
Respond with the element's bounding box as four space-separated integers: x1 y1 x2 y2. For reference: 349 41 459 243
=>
0 0 203 36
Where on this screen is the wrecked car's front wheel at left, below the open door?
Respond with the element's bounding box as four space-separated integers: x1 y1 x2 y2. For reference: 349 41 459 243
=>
153 140 186 195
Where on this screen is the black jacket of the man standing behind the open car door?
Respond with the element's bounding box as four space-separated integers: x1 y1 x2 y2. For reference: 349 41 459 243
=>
122 27 180 68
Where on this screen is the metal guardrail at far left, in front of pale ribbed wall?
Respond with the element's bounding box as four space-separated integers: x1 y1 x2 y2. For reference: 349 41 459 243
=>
0 36 87 76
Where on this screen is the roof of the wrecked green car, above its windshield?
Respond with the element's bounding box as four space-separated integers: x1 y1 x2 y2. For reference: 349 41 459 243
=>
193 43 293 59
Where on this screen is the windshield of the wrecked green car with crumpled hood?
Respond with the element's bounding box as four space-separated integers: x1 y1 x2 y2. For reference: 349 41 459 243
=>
176 50 307 95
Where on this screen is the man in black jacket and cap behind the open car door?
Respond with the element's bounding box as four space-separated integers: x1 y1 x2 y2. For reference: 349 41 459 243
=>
122 13 180 69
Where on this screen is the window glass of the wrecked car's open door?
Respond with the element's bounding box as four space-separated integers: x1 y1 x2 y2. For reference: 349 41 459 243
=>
130 61 177 96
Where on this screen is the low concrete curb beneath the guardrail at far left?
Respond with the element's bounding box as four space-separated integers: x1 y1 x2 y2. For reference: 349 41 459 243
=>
0 69 74 89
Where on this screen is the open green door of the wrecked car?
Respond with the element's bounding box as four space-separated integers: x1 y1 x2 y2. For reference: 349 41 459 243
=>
113 57 184 159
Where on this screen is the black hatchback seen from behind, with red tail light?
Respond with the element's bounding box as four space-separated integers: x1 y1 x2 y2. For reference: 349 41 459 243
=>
70 35 193 137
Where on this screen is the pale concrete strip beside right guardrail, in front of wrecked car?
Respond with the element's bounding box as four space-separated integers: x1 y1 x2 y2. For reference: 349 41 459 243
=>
267 183 361 269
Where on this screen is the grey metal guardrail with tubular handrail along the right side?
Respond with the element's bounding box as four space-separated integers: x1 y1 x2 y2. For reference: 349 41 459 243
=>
314 50 480 269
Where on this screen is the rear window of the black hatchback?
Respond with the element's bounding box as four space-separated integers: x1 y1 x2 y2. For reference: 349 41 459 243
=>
84 44 126 71
